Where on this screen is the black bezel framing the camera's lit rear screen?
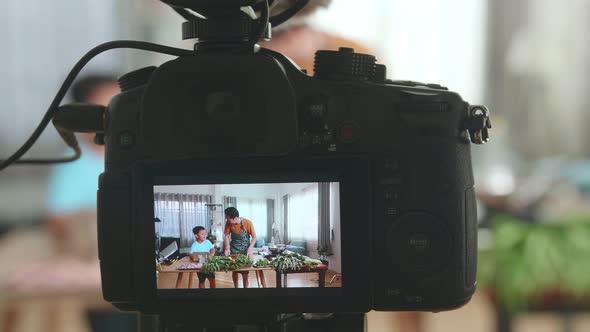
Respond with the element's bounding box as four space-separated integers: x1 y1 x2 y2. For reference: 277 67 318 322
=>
132 157 372 312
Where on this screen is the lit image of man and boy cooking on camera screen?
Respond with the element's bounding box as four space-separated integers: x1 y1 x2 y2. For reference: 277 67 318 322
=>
154 182 342 289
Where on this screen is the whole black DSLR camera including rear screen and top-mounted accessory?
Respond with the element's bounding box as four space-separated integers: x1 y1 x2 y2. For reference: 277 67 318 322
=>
55 0 490 313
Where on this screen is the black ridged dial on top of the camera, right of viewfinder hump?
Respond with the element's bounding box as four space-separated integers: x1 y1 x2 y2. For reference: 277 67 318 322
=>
314 47 377 81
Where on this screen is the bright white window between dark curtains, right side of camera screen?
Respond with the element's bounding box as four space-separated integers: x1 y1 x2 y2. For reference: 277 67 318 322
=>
288 183 319 243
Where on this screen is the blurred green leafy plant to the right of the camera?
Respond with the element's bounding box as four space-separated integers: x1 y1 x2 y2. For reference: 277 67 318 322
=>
478 216 590 310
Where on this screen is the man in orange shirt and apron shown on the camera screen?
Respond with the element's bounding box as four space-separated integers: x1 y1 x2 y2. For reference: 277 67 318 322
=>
224 207 256 288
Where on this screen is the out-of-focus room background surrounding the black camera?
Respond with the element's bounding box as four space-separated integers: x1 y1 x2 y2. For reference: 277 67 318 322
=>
0 0 590 332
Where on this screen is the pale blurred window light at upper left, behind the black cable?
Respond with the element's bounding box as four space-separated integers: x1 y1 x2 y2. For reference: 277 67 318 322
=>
0 0 123 153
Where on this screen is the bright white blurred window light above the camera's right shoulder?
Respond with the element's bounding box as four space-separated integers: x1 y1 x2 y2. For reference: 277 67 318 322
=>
313 0 487 103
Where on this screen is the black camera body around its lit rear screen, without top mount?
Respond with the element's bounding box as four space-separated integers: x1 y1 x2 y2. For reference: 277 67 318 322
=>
98 49 477 313
